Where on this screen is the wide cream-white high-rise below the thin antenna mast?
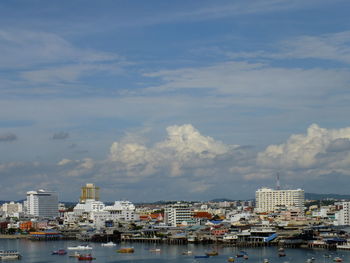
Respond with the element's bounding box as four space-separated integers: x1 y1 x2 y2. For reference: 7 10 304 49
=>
255 188 305 212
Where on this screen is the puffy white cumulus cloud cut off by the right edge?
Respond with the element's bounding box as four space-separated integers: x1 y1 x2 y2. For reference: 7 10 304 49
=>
258 124 350 168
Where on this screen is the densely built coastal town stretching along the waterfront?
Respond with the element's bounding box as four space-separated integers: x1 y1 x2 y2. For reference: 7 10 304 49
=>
0 183 350 255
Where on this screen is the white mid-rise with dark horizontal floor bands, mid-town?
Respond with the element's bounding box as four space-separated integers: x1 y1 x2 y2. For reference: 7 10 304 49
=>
164 203 194 226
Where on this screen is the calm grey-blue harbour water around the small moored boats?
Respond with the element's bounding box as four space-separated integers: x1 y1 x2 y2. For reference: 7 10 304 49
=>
0 239 350 263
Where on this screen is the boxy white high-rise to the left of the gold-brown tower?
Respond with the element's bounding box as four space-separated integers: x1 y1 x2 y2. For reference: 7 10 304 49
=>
26 189 58 218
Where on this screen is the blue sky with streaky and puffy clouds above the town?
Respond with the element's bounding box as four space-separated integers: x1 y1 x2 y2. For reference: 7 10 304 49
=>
0 0 350 202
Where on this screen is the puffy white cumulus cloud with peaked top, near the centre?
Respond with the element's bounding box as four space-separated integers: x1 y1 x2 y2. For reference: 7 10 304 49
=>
109 124 237 176
